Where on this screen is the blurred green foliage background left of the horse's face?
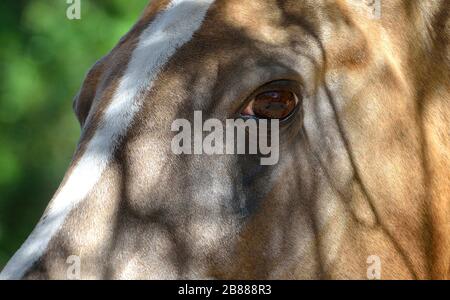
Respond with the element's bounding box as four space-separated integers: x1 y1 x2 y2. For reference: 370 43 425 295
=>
0 0 148 269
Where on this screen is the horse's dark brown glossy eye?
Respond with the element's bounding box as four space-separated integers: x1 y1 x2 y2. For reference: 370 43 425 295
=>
242 90 299 119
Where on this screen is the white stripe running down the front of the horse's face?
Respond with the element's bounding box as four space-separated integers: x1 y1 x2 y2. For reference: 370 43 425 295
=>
0 0 214 279
